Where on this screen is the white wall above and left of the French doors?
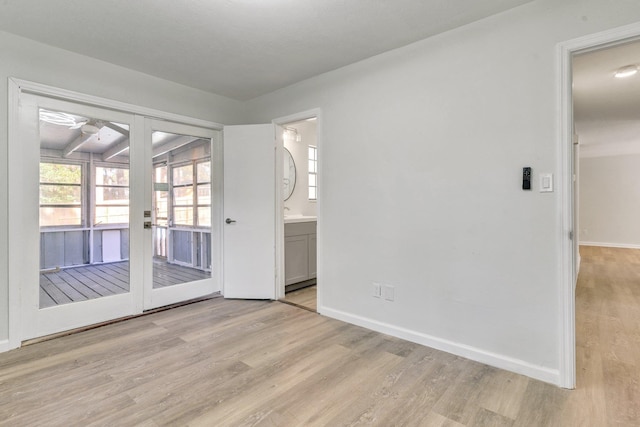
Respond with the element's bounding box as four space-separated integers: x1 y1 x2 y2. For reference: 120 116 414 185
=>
0 32 243 347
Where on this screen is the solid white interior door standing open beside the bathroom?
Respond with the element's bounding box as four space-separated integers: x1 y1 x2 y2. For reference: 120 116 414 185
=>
223 124 276 299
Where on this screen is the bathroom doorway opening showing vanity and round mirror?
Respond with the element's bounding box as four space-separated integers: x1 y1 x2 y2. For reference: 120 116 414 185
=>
276 112 320 311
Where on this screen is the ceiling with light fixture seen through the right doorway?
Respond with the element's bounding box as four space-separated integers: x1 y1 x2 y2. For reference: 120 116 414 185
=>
573 41 640 151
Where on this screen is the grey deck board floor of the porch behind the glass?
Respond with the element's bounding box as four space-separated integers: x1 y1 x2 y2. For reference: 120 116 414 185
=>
40 260 211 308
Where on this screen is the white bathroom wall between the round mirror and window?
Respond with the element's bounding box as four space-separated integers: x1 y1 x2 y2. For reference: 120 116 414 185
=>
284 121 317 216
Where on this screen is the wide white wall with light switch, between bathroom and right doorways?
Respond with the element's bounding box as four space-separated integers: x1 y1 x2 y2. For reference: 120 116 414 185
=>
242 0 640 381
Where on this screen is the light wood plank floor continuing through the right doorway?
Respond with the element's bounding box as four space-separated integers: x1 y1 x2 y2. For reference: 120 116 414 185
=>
0 248 640 427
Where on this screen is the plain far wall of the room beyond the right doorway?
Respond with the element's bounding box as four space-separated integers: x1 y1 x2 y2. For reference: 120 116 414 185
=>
579 154 640 248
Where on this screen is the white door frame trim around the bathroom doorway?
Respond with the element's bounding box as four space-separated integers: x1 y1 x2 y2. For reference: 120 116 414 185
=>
272 108 324 313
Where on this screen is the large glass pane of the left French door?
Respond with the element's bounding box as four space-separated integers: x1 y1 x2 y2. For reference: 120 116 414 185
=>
38 108 130 308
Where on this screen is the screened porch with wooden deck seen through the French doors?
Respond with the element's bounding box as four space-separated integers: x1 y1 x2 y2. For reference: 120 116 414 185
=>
39 109 211 308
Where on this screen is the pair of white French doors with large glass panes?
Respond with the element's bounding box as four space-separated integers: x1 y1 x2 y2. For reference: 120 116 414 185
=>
9 93 221 340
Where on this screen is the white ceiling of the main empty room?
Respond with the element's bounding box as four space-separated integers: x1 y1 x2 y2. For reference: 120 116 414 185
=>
0 0 531 100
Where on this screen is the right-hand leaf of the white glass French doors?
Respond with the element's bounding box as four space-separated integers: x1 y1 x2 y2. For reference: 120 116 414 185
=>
146 122 219 308
